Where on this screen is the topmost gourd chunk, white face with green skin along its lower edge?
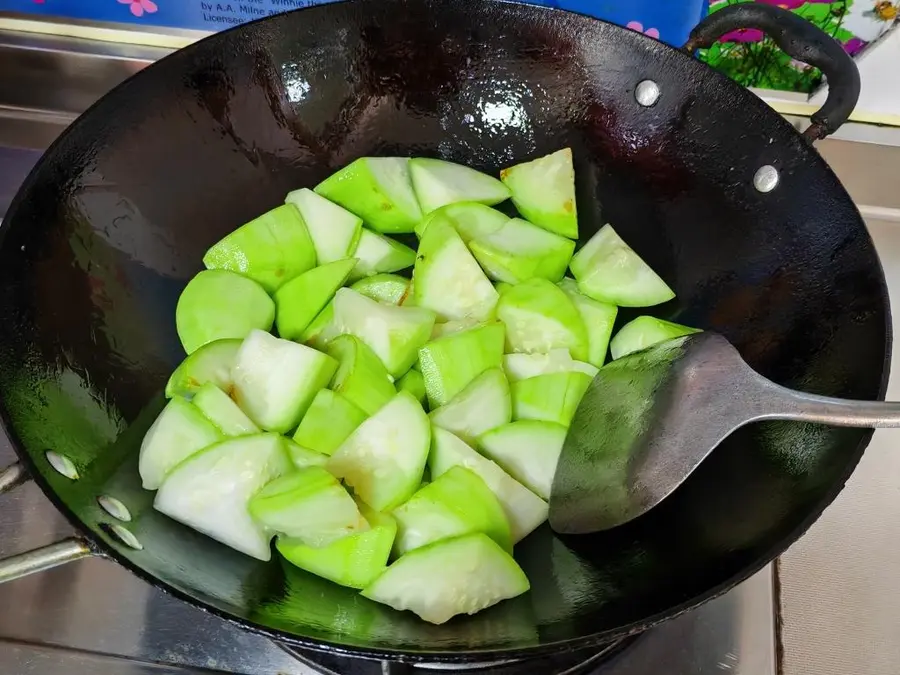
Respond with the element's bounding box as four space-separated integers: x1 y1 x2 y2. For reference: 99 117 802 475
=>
500 148 578 239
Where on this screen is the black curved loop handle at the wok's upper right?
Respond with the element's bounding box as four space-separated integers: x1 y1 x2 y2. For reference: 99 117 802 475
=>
683 2 860 142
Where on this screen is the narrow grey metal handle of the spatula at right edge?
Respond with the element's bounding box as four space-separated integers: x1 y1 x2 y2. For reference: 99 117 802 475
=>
766 385 900 428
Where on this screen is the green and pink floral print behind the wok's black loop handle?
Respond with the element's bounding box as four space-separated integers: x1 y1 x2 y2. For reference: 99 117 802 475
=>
701 0 900 93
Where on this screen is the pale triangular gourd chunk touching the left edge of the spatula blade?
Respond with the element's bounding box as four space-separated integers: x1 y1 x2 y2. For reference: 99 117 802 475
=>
478 420 567 499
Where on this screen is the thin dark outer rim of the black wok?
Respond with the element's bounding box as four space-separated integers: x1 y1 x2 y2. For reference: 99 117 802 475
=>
0 0 893 664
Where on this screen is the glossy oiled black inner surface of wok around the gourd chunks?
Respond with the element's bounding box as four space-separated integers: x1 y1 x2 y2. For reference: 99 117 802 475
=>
0 2 888 659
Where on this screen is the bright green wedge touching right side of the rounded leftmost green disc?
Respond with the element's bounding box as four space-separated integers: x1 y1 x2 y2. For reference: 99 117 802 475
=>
275 258 356 340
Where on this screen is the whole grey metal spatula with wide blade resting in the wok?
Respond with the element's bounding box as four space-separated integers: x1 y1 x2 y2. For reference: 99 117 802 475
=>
550 333 900 534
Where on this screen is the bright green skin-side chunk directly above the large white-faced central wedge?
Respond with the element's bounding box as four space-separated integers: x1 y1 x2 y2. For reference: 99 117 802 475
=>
328 335 397 414
